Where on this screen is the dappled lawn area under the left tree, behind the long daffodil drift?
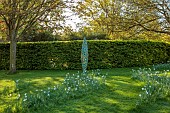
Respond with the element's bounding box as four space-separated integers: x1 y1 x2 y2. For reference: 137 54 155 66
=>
0 70 66 113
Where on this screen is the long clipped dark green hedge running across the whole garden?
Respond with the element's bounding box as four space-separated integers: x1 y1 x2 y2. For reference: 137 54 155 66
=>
0 41 170 70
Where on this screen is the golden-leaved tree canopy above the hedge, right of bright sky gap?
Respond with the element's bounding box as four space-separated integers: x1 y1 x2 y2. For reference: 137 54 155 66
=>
72 0 170 37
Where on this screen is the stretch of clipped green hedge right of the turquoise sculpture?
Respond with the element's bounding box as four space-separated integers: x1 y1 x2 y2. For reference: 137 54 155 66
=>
88 41 169 68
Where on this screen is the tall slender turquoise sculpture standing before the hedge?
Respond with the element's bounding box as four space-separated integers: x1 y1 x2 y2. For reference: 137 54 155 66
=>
81 37 88 74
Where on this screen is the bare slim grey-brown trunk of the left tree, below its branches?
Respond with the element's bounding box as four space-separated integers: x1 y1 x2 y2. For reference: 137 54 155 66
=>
9 30 17 74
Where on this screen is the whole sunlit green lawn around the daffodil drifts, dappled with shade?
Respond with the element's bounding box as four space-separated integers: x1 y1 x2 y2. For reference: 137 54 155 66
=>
0 68 170 113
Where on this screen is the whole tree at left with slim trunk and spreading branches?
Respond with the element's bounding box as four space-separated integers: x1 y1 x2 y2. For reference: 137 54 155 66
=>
0 0 64 74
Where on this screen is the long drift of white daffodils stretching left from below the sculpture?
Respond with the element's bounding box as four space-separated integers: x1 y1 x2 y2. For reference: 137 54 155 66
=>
5 70 106 112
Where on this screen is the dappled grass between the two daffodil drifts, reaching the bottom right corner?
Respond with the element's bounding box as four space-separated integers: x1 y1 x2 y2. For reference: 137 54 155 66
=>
49 76 170 113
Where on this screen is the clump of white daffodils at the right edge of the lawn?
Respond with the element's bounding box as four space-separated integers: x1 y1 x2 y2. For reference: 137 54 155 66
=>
132 68 170 105
